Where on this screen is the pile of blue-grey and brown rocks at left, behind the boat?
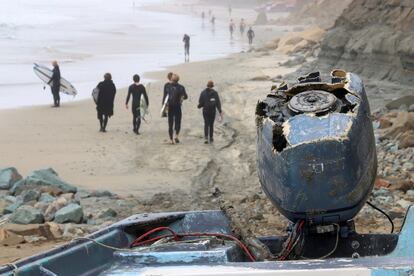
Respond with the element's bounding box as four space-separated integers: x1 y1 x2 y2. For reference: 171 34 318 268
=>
0 168 123 245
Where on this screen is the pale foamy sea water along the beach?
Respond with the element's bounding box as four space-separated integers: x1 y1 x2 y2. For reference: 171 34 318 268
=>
0 0 252 109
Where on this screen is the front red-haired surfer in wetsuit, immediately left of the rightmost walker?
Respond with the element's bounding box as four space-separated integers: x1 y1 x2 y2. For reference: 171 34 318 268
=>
167 74 188 144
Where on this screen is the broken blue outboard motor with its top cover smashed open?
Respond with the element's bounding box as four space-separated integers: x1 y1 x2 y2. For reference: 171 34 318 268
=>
256 70 377 225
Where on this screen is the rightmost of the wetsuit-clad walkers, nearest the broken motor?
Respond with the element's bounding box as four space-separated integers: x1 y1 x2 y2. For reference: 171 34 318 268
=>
198 81 223 144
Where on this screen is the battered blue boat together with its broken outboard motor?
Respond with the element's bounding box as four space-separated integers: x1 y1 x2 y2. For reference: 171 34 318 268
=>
0 70 414 276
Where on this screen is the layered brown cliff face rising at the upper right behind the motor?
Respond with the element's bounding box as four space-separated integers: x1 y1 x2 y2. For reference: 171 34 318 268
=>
318 0 414 84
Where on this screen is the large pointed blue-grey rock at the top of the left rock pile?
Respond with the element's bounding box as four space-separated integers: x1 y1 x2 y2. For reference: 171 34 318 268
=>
11 168 77 195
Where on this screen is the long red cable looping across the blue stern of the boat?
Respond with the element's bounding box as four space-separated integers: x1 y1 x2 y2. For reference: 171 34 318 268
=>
131 227 256 262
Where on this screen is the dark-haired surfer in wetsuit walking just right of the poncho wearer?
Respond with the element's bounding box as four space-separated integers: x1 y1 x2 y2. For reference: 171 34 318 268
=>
125 75 149 135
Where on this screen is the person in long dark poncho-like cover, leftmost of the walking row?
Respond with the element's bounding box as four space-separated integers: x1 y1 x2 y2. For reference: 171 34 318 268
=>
96 73 116 132
